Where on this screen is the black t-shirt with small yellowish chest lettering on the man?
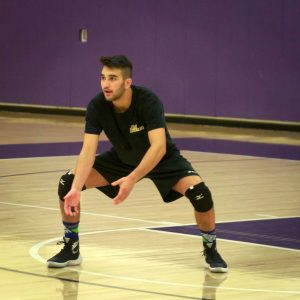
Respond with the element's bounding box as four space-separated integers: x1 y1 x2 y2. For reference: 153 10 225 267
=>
85 86 178 166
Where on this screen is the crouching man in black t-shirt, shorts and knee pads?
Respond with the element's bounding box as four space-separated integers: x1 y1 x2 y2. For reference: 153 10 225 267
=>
48 55 227 272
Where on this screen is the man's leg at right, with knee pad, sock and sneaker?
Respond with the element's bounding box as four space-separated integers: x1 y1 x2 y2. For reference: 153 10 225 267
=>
173 176 228 273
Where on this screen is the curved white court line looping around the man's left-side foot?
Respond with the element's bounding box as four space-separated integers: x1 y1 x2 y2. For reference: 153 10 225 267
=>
29 227 300 295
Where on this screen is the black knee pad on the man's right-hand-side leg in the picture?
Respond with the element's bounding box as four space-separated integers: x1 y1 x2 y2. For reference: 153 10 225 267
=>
185 182 214 212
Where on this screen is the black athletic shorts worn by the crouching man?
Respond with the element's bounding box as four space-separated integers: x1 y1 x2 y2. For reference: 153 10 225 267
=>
93 150 199 202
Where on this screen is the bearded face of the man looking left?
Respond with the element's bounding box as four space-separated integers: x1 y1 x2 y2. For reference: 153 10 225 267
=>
101 66 130 101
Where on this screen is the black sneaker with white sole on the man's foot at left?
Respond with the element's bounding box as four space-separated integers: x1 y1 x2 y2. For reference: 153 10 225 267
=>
47 238 82 268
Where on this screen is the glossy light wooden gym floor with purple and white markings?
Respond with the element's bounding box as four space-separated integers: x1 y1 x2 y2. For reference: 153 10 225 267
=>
0 112 300 300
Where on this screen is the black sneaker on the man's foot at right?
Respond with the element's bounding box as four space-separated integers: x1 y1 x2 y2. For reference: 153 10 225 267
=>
203 241 228 273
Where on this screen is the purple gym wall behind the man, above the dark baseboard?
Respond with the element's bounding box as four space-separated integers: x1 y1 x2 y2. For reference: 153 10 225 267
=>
0 0 300 121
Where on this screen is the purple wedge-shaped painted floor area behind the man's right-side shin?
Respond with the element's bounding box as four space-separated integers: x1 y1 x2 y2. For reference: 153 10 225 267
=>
151 217 300 250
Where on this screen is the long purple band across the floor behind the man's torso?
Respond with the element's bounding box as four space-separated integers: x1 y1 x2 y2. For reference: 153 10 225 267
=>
0 138 300 160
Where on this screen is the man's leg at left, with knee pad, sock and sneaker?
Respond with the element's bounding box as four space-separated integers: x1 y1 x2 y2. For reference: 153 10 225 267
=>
47 169 109 268
